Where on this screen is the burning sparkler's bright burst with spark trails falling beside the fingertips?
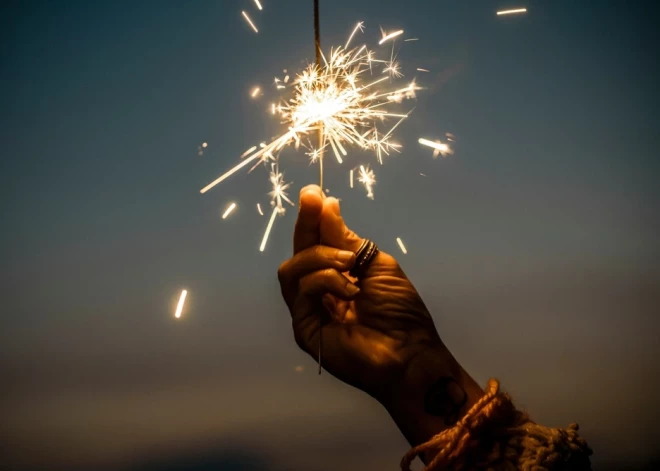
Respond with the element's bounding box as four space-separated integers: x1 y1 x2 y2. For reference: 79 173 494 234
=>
201 19 420 251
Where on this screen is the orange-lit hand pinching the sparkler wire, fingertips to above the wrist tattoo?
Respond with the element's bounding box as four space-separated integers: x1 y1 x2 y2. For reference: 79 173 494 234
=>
278 186 452 402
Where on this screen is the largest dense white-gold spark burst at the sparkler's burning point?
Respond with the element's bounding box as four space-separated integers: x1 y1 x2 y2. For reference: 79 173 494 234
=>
200 20 420 193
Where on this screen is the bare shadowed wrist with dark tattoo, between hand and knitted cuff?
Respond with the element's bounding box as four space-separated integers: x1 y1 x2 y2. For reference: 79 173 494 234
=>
380 346 484 456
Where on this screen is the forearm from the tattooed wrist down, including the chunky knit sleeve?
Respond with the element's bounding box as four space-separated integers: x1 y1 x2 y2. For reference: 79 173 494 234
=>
381 347 591 471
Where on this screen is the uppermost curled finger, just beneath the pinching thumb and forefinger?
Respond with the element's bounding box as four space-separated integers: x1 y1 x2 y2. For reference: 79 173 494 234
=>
277 245 355 307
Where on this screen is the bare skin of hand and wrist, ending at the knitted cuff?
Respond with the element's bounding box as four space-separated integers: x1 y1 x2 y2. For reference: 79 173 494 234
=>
278 185 483 456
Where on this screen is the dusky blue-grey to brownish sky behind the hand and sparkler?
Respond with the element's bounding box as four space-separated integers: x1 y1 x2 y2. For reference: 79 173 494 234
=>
0 0 660 471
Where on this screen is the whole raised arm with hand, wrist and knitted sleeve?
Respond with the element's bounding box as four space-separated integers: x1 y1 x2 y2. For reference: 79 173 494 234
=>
278 186 591 471
